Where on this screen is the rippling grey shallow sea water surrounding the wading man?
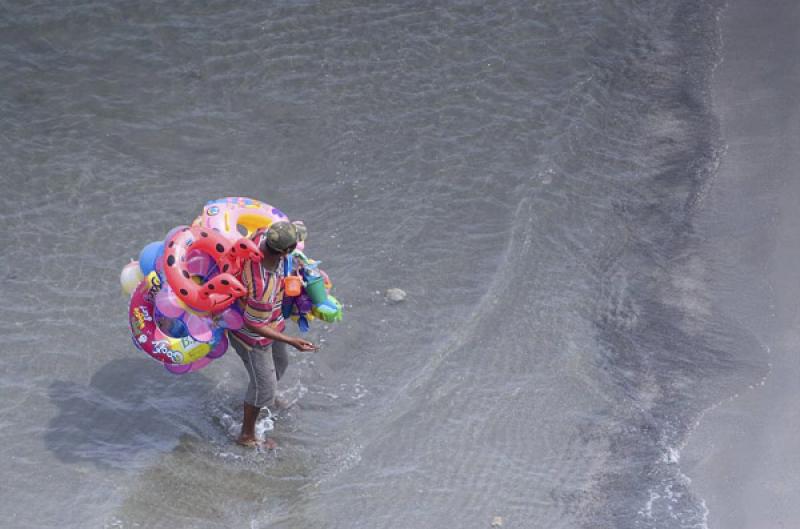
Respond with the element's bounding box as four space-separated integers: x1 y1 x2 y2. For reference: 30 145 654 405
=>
0 0 764 528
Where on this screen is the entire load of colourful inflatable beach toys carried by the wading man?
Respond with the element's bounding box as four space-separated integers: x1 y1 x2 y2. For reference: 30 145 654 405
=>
120 197 342 374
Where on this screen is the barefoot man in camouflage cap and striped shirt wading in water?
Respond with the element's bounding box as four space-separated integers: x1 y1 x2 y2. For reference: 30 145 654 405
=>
230 221 317 449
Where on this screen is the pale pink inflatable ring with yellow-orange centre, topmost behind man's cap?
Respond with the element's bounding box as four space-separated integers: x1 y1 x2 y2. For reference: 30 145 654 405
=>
192 197 303 250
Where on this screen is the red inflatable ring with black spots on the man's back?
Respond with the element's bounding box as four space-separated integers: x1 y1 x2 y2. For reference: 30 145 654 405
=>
164 226 263 312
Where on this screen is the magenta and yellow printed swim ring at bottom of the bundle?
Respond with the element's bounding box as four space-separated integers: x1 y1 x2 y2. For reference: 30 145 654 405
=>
128 280 225 364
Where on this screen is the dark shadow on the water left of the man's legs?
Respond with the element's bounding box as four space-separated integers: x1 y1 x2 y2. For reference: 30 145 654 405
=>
45 358 219 468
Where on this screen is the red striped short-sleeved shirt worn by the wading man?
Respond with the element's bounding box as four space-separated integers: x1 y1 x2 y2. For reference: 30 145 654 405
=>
230 229 286 348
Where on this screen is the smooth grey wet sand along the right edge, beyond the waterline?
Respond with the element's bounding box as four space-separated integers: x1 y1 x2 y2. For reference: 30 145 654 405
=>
682 0 800 529
